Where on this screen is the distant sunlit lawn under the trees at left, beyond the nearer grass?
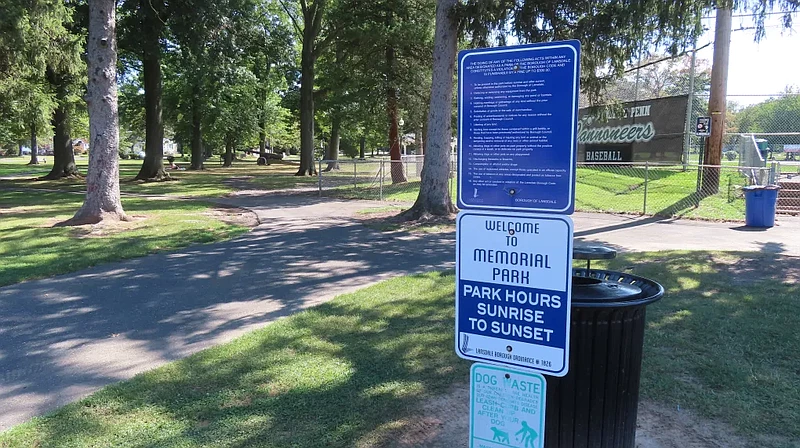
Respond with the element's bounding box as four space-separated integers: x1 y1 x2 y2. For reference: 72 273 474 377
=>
0 157 316 198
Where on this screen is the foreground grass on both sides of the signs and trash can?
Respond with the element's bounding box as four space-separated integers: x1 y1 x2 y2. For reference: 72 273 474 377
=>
0 252 800 448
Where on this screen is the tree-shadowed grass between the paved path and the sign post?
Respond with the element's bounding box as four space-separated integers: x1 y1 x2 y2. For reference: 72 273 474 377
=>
1 273 462 448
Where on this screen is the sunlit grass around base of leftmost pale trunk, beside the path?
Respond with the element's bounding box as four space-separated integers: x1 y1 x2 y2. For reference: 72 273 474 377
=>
0 189 248 286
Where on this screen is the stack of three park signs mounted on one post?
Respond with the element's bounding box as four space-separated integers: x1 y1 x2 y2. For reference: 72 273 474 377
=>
455 41 580 448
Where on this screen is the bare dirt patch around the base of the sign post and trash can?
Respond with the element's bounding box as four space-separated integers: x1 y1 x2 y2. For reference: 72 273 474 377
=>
372 385 763 448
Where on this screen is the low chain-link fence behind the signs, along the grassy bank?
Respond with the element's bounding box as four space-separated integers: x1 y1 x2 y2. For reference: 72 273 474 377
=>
318 156 800 221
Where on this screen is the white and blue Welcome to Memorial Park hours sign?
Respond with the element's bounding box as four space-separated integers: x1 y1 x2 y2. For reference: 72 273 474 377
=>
456 211 573 376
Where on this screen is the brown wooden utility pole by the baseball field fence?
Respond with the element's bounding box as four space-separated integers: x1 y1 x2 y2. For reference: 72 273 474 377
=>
701 6 732 195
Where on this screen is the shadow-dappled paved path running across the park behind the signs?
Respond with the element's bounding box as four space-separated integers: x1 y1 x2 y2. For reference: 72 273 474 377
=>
0 195 800 430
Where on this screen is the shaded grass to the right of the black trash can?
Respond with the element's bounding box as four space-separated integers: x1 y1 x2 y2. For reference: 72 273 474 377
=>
597 252 800 447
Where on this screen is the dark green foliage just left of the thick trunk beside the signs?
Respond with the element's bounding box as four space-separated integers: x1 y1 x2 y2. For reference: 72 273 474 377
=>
318 0 435 152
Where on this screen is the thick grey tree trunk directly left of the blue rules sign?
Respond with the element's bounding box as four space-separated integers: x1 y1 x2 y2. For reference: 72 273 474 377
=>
401 0 458 220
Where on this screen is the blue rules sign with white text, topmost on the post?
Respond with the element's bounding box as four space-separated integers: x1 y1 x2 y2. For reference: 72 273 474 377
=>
458 41 580 214
